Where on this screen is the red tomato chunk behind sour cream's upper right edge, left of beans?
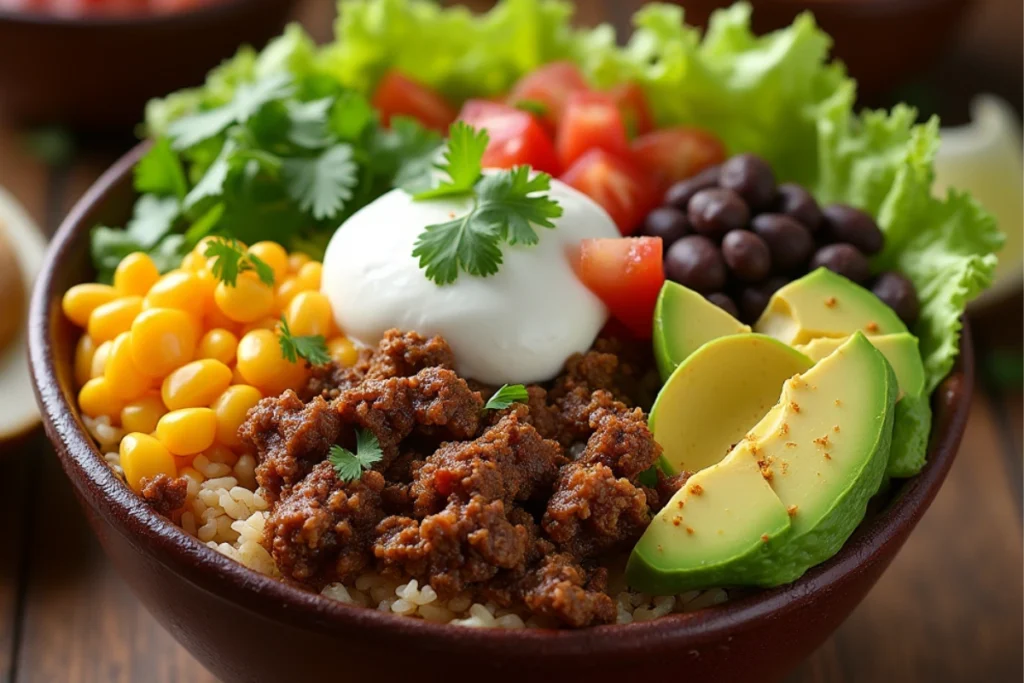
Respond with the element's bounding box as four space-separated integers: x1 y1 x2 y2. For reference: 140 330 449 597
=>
561 150 657 234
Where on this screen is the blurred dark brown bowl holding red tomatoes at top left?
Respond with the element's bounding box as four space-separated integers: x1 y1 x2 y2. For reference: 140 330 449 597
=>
0 0 296 129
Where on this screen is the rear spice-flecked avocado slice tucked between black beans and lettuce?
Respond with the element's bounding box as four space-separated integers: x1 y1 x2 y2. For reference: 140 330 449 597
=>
754 268 907 345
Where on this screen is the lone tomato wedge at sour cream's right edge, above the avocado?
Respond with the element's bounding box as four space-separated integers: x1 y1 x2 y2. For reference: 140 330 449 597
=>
575 238 665 339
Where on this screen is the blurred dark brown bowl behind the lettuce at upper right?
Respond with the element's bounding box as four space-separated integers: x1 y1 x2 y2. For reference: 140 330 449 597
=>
671 0 974 97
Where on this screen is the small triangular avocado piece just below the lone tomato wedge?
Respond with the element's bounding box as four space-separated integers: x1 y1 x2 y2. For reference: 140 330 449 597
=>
654 281 751 382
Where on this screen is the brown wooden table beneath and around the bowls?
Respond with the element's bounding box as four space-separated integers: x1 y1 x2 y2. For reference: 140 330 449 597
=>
0 0 1024 683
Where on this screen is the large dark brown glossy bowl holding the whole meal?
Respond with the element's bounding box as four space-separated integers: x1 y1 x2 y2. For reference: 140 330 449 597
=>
29 144 974 683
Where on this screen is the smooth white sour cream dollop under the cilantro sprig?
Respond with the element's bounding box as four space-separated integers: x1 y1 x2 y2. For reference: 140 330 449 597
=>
322 180 618 385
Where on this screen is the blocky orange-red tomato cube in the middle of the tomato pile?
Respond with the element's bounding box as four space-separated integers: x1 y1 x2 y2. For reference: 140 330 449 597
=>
555 92 630 168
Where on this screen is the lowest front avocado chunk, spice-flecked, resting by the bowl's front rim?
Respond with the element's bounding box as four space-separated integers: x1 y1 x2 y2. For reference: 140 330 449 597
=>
626 443 790 595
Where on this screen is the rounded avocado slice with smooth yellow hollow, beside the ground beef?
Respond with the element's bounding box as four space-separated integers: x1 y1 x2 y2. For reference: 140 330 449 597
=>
647 333 812 474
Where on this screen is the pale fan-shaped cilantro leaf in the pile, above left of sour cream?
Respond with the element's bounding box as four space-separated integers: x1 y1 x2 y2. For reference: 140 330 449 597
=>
282 143 359 220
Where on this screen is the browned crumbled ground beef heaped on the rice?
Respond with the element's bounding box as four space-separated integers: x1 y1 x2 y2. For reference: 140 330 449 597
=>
234 330 659 627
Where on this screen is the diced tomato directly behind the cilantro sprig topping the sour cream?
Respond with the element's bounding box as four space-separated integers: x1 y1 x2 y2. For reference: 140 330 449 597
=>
459 99 561 175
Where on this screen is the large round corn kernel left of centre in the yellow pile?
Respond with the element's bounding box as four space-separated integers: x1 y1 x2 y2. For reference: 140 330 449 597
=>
131 308 196 377
